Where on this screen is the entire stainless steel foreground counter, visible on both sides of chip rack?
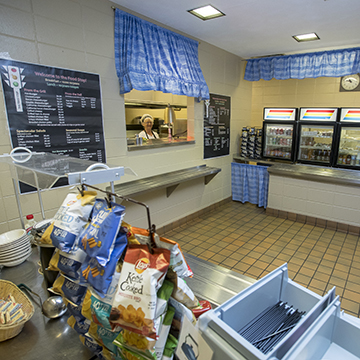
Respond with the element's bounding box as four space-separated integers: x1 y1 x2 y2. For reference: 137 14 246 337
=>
0 248 255 360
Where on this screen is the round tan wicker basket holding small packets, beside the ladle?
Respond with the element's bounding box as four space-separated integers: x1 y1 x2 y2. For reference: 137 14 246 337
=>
0 280 35 342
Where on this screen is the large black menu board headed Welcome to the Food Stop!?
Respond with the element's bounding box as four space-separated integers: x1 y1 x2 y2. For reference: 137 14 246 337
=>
0 59 106 163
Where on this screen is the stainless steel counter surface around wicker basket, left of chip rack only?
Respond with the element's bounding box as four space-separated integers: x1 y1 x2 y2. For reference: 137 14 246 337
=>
0 248 93 360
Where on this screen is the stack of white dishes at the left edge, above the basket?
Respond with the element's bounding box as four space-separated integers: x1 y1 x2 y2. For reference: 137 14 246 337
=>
0 229 31 267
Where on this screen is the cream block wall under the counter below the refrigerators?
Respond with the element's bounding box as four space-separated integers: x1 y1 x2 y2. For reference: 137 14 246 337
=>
268 175 360 226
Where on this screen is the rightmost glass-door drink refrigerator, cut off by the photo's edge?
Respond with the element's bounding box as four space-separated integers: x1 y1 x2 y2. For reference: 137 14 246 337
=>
335 108 360 170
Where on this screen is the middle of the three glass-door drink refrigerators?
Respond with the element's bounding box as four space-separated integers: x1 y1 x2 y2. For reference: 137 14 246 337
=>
296 108 339 166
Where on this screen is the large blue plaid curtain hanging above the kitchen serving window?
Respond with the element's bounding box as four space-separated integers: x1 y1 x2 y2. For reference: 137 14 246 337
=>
115 9 209 100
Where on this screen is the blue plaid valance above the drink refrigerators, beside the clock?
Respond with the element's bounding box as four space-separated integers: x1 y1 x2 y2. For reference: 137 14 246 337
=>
244 48 360 81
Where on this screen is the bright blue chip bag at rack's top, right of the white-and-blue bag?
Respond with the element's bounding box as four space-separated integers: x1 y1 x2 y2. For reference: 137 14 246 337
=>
79 199 125 266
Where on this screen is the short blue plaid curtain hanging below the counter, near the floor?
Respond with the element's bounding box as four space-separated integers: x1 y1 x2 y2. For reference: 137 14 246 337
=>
231 163 269 209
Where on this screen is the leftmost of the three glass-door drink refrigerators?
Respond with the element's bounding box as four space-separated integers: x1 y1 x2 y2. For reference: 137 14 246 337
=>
262 108 297 161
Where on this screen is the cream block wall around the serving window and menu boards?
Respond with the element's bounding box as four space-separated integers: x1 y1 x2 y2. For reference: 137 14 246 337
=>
0 0 252 233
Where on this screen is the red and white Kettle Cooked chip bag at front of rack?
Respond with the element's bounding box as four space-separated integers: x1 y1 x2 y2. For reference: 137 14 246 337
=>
109 245 170 339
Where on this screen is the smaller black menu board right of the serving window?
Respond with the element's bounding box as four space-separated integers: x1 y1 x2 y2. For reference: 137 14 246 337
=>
204 94 230 159
